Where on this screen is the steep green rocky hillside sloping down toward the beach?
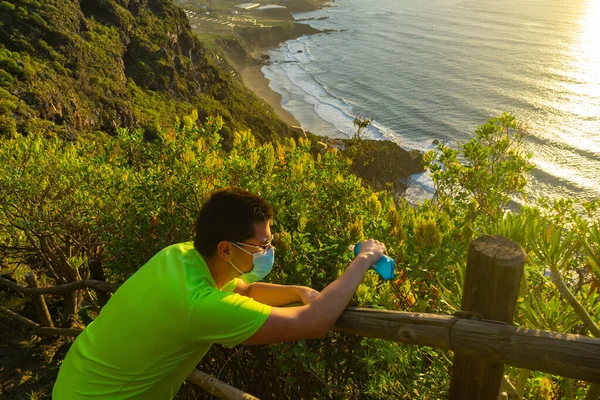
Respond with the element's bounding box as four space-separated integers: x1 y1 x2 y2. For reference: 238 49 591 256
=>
0 0 289 143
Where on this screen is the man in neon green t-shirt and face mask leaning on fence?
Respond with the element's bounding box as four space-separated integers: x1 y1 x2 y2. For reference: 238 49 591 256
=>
52 188 385 400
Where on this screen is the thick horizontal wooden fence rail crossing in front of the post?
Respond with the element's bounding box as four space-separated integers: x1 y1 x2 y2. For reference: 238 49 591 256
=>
335 308 600 383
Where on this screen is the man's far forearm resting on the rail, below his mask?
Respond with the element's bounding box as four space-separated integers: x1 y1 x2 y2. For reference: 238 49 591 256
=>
234 280 319 307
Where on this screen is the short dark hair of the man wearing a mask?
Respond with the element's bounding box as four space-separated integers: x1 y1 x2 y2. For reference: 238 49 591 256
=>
194 187 273 257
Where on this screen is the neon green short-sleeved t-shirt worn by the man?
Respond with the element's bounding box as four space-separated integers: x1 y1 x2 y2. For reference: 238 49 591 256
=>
52 242 271 400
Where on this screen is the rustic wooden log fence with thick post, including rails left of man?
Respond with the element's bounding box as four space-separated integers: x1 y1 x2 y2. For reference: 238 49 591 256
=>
0 236 600 400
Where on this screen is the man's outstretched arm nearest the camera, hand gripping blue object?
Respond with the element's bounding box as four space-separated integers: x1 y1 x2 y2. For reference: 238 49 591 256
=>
244 240 385 344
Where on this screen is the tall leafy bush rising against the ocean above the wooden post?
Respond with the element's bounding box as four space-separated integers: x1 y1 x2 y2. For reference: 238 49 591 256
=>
424 113 533 222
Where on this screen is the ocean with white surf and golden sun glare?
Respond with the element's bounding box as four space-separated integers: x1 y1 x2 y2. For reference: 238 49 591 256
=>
262 0 600 202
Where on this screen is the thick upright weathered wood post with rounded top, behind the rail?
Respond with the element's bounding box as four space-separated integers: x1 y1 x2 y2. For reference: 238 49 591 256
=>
449 236 525 400
